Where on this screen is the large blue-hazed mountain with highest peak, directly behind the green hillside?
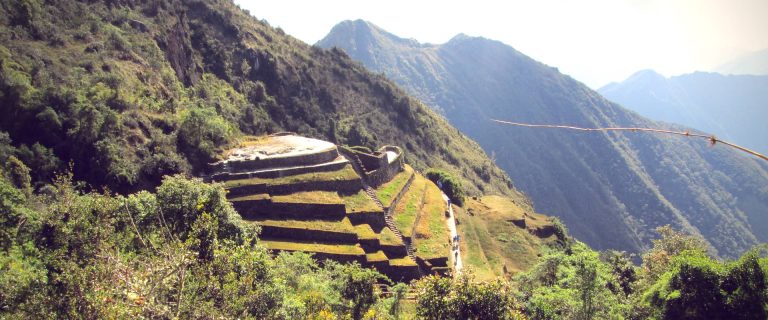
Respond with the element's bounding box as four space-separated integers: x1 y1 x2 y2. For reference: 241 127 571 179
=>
317 20 768 257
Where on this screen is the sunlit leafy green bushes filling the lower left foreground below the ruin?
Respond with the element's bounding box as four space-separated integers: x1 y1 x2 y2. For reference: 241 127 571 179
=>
0 176 404 319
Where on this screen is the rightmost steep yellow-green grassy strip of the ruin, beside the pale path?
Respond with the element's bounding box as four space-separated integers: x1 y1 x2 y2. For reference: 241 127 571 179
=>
413 183 451 260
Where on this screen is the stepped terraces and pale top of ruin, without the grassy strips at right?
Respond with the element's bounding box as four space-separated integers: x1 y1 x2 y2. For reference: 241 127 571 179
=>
208 133 444 281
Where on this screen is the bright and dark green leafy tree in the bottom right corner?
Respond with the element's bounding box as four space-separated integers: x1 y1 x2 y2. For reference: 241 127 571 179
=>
633 226 768 319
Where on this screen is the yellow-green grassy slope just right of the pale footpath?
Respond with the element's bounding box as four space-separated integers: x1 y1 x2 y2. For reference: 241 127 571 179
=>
454 196 555 280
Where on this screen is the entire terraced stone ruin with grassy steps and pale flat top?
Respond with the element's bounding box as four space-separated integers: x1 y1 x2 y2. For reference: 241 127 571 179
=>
209 134 452 281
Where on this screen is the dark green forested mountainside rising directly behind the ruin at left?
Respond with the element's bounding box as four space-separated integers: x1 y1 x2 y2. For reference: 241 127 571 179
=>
0 0 522 199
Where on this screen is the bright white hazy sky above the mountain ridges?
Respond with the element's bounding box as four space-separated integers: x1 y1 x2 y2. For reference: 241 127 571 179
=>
235 0 768 88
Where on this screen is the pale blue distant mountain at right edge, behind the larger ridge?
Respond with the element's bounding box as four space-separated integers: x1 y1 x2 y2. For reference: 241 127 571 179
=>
598 70 768 154
